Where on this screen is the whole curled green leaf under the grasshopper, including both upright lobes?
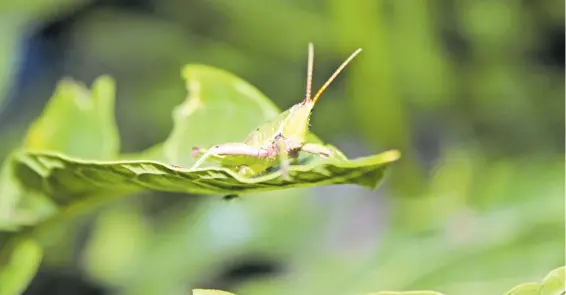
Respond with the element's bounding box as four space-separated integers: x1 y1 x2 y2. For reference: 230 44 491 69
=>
6 65 399 206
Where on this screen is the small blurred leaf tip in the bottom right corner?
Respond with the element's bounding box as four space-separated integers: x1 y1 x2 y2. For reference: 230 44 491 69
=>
505 267 566 295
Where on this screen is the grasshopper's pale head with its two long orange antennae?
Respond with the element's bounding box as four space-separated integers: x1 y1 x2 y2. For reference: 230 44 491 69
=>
281 43 362 148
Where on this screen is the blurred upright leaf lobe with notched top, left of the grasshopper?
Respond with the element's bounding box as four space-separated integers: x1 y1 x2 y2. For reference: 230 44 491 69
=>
25 76 120 160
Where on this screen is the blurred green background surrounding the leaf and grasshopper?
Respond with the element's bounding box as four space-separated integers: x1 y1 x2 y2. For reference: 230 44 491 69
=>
0 0 565 295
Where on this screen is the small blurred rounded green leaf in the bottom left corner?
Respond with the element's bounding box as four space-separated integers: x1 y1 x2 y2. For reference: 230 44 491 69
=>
0 236 43 295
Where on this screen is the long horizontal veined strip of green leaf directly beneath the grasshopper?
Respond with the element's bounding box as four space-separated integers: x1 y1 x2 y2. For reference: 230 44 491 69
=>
10 151 399 200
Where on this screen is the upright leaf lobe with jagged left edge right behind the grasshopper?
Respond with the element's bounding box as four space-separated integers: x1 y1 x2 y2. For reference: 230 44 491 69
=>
163 65 279 166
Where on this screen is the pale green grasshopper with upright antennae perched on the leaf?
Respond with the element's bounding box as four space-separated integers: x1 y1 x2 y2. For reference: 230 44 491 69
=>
191 43 362 179
